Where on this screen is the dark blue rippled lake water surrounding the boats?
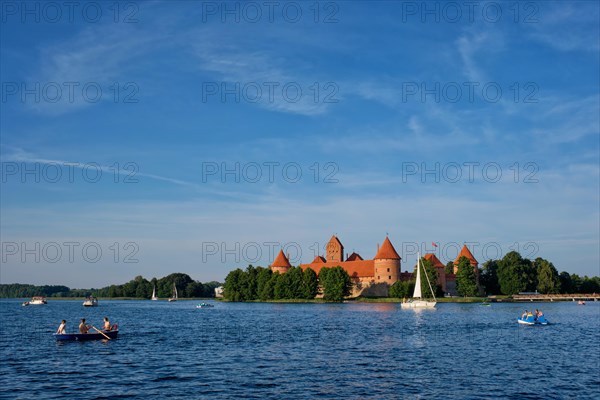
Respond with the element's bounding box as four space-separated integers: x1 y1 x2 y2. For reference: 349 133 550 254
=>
0 299 600 400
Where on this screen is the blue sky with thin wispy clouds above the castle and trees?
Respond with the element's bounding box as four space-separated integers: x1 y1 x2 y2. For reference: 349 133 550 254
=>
0 1 600 287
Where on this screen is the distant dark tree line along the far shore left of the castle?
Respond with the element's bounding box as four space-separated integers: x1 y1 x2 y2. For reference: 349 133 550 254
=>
0 273 221 299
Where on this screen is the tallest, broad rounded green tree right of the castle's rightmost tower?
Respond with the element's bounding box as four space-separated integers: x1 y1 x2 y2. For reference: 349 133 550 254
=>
498 251 537 295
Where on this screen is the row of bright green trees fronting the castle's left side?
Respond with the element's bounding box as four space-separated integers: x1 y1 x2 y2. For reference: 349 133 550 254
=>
223 265 352 301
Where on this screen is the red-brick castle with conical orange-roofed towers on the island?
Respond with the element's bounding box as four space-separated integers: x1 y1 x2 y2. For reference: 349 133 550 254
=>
271 235 479 296
